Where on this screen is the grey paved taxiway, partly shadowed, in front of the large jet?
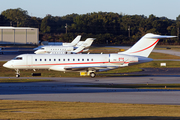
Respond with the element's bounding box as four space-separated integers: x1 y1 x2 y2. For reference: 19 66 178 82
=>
0 76 180 105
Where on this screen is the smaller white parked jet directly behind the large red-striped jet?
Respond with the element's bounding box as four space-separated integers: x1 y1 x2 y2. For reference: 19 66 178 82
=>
34 38 95 54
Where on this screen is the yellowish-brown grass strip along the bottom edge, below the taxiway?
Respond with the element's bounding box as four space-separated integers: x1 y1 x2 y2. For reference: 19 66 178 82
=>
0 100 180 120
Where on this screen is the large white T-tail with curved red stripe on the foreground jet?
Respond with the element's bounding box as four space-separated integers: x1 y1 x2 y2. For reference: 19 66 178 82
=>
118 33 176 57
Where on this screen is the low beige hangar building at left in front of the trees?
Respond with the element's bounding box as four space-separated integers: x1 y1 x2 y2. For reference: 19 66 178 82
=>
0 27 39 45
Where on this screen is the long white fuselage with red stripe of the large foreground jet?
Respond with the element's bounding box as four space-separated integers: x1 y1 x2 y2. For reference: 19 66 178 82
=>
3 54 146 72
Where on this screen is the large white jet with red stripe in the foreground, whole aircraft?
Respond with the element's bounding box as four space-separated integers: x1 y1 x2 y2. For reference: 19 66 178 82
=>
3 33 176 77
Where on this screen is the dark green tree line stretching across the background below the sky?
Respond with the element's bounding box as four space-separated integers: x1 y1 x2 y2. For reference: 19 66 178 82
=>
0 8 180 45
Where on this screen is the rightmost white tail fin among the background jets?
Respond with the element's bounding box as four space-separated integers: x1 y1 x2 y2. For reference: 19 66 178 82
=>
73 38 95 53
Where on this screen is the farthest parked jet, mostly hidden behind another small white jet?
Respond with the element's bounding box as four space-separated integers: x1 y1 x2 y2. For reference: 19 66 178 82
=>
33 35 81 50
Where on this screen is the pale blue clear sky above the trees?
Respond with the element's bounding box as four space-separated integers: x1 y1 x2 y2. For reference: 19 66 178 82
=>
0 0 180 20
